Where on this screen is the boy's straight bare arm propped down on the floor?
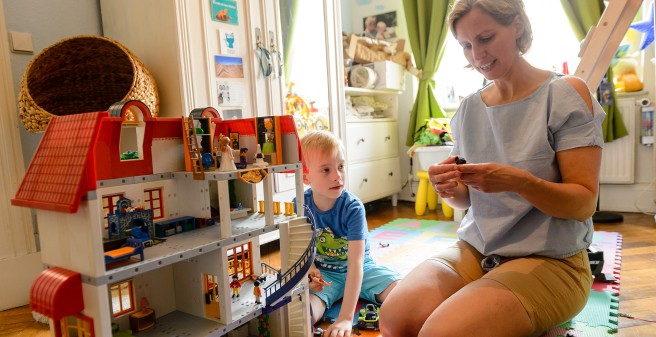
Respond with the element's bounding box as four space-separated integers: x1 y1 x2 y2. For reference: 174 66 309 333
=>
328 240 364 335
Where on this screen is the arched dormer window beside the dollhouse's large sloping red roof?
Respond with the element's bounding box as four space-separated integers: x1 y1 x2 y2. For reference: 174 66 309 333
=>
119 106 146 161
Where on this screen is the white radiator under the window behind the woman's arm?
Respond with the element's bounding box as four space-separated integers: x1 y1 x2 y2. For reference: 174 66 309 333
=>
599 92 645 184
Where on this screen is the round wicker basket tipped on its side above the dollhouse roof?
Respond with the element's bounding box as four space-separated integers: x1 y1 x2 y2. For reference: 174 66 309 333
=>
18 36 159 132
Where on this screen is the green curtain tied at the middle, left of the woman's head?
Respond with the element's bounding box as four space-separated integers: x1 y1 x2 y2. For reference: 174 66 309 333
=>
403 0 453 146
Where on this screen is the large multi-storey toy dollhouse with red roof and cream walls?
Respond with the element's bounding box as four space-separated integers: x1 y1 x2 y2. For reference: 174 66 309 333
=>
12 101 315 336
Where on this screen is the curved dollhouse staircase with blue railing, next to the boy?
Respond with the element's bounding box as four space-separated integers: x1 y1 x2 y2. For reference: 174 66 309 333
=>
264 217 316 337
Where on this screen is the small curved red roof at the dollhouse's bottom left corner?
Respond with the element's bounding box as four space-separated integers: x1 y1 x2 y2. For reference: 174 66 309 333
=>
30 266 84 321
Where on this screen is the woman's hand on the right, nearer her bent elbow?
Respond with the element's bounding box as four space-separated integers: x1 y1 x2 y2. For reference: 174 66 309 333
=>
457 163 527 193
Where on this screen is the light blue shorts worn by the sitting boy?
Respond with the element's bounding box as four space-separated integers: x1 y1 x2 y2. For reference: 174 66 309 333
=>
310 257 401 309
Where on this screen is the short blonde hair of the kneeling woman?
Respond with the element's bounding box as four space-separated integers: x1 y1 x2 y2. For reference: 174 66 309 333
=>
449 0 533 54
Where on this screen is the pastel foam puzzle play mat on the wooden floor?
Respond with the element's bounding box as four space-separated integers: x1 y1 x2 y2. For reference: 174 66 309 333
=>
369 219 622 337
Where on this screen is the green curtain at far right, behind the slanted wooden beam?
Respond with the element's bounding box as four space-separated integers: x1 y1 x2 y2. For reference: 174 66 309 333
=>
560 0 629 142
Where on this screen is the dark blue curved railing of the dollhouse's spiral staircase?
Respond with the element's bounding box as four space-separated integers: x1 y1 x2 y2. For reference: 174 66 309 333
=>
264 219 317 310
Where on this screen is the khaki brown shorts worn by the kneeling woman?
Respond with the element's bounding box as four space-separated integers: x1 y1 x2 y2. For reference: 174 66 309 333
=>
431 241 592 333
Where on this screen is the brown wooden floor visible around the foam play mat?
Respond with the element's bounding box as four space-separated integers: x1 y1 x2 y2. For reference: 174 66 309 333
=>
0 201 656 337
